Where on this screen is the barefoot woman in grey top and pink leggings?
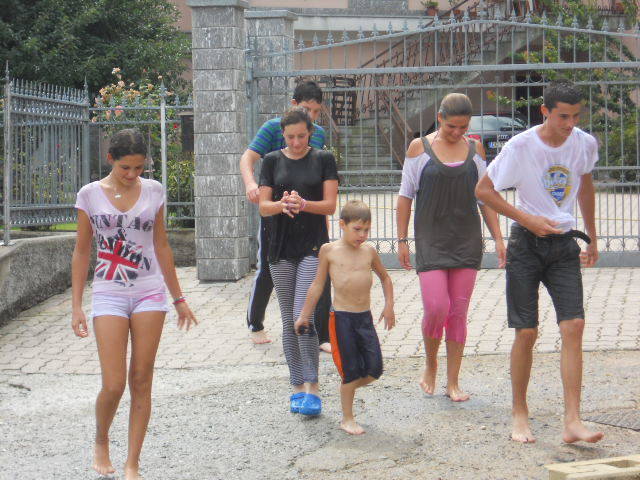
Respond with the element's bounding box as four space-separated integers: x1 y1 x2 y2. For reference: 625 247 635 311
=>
396 93 506 402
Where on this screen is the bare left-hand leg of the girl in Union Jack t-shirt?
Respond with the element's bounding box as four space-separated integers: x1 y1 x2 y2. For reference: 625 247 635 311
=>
93 315 129 475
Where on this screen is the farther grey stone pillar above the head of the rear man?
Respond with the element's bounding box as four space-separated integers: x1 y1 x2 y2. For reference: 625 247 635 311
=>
245 10 298 133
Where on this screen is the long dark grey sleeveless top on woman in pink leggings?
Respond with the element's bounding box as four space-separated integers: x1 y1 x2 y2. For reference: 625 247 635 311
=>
414 137 482 272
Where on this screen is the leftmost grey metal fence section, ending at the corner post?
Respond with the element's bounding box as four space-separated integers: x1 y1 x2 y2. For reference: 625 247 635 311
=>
2 71 89 245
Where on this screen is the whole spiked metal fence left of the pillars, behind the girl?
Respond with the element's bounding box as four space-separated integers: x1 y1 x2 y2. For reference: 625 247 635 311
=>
0 71 194 245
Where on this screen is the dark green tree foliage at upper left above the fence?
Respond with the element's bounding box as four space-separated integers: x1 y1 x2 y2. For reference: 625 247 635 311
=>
0 0 190 94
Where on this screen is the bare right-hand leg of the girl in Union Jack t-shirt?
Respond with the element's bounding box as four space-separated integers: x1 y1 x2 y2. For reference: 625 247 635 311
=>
124 311 165 480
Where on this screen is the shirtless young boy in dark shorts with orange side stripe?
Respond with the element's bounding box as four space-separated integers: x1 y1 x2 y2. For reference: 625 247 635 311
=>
295 200 396 435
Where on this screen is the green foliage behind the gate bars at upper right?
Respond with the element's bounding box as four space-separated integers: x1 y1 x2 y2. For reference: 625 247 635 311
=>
487 0 639 173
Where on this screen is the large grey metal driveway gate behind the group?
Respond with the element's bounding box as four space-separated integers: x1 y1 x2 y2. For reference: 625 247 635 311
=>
248 2 640 266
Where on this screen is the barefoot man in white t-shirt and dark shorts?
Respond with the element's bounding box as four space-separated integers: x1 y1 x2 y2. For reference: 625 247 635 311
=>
476 82 603 443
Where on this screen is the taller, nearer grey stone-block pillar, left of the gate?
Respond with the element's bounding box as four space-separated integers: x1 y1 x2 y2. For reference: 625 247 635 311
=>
187 0 249 280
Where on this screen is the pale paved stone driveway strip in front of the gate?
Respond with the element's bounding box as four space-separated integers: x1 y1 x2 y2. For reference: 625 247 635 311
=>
0 267 640 374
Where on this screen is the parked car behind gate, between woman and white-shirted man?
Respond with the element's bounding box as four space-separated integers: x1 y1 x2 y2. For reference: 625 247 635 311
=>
467 113 529 163
